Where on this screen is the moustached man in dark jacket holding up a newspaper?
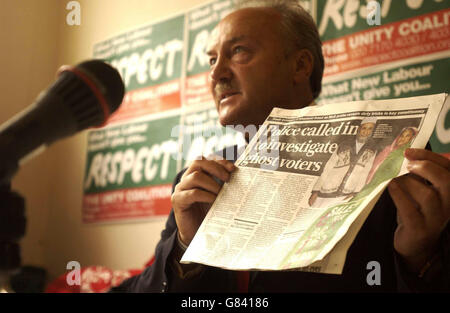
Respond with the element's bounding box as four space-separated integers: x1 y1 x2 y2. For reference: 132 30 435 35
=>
114 1 450 292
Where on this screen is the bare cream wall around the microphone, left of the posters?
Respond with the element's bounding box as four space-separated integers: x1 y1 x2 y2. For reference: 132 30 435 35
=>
0 0 207 279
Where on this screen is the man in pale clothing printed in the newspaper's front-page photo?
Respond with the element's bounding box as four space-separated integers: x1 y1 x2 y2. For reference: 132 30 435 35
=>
309 117 377 208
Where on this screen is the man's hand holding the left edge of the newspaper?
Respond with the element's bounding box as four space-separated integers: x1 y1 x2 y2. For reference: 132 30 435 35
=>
172 158 236 245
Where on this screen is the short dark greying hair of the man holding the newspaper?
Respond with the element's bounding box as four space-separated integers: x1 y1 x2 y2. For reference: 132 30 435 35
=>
235 0 324 99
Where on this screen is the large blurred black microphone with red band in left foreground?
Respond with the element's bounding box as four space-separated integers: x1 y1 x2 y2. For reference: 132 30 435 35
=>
0 60 125 184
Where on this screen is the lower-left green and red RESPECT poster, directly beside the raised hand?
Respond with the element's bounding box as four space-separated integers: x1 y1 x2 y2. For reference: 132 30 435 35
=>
82 111 180 223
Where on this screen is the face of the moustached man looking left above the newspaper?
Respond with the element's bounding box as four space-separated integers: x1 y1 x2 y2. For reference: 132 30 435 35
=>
207 8 298 126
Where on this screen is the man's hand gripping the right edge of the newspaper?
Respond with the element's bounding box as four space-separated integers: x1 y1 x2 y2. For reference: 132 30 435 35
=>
389 149 450 272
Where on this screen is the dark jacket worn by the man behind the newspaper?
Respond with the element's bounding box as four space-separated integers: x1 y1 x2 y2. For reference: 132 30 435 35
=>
111 145 450 292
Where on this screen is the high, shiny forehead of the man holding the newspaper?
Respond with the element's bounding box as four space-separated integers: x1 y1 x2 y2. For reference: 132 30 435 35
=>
207 8 280 51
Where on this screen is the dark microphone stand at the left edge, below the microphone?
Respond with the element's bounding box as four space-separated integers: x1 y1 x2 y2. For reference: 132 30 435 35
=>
0 162 26 293
